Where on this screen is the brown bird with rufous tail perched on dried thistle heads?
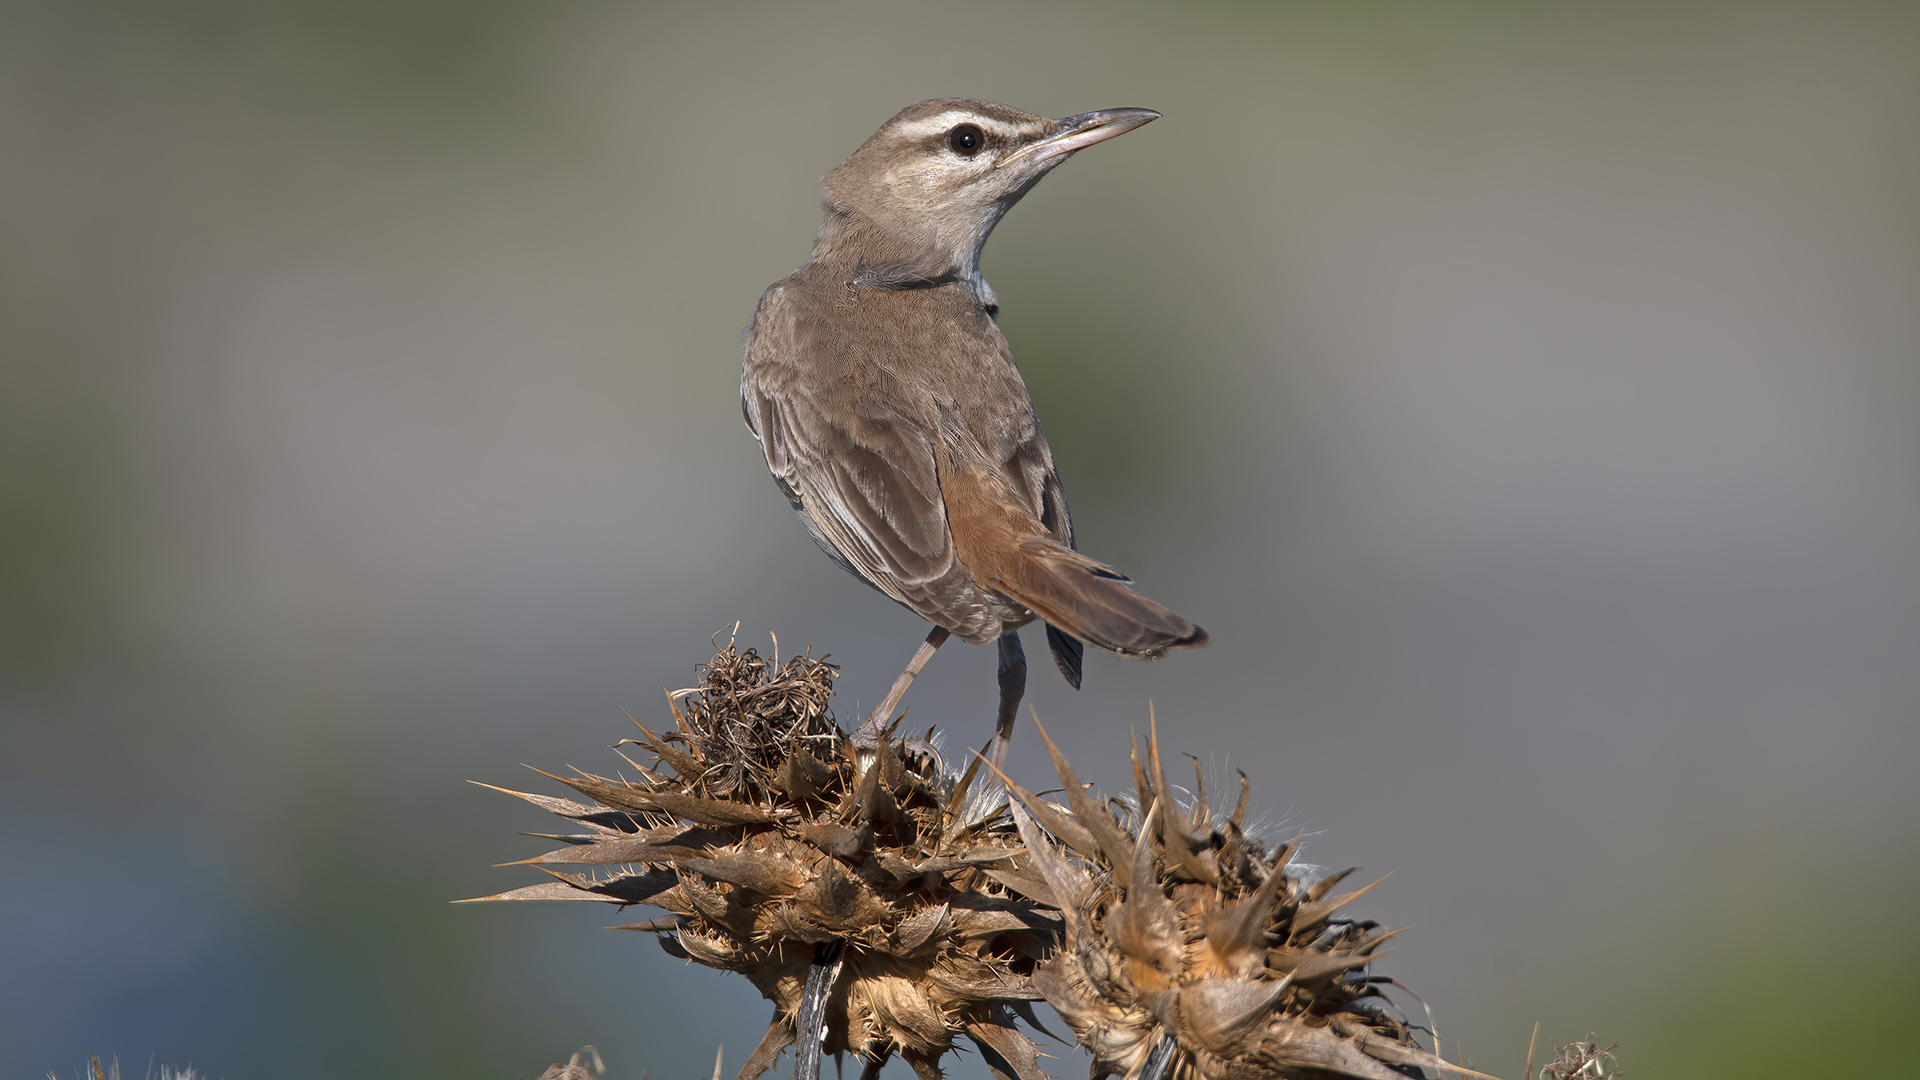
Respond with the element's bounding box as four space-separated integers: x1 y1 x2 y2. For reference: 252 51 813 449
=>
741 98 1208 765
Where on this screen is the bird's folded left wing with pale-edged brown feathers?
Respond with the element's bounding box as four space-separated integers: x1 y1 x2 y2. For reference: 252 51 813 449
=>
741 284 998 642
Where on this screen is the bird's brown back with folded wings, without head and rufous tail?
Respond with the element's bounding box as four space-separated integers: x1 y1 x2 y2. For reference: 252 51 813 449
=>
741 259 1073 642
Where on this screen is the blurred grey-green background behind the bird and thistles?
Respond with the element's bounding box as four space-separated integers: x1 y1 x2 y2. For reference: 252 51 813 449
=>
0 0 1920 1080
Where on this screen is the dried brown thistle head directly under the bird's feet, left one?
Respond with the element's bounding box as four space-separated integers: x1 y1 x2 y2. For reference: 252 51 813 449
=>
470 630 1058 1080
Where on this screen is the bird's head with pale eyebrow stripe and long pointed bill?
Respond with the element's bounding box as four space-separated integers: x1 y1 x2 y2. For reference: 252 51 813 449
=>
822 98 1160 279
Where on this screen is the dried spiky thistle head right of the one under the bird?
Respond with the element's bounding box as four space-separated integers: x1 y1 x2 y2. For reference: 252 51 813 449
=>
993 724 1457 1080
